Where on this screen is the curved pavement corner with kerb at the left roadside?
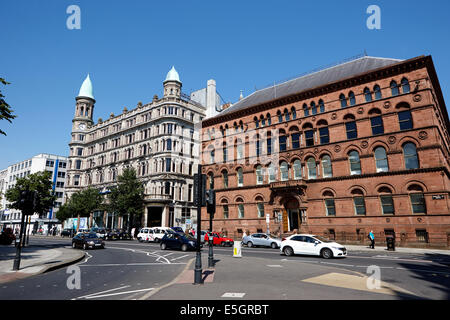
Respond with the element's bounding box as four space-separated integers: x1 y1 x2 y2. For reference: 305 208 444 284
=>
0 245 85 283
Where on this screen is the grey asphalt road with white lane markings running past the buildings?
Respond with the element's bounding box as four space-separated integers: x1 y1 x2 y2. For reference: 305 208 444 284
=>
0 238 450 300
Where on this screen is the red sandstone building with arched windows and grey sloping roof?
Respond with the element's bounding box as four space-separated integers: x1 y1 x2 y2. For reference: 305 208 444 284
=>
202 56 450 247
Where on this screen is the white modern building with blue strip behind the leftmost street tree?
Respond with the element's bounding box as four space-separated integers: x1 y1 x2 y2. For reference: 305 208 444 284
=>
0 153 67 231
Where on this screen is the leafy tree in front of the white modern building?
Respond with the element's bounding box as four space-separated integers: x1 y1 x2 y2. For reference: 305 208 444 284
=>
5 171 56 216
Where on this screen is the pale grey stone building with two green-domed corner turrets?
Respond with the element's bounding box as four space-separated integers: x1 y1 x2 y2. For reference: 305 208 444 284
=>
67 68 218 228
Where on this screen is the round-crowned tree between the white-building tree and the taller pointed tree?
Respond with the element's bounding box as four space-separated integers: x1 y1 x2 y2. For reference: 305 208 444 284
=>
63 187 103 232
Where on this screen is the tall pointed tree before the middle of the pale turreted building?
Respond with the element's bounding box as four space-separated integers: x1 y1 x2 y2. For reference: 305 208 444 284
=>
107 168 144 233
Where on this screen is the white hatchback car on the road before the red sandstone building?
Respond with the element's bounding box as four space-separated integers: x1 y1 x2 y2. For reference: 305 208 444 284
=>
280 234 347 259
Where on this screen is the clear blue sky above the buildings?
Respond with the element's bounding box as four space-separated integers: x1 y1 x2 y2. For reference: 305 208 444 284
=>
0 0 450 169
